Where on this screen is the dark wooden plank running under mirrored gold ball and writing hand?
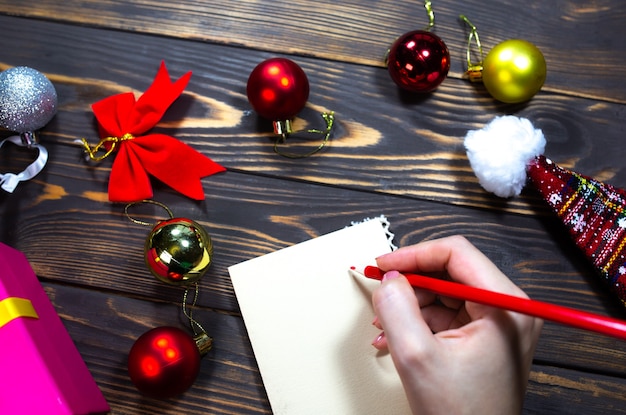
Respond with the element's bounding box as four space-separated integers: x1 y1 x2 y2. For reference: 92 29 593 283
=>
0 136 626 373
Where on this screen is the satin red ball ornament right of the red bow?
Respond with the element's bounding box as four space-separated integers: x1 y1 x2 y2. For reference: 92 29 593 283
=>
246 58 309 121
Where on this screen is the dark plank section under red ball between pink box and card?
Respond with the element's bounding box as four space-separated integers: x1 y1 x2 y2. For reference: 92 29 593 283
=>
45 284 270 414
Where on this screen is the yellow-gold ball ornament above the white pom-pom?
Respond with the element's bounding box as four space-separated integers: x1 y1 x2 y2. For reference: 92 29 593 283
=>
482 39 547 104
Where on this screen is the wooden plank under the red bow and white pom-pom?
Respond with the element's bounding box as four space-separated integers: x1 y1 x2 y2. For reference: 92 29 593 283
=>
0 17 626 214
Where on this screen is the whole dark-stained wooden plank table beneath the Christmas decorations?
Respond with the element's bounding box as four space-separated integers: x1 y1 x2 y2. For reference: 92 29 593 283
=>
0 0 626 414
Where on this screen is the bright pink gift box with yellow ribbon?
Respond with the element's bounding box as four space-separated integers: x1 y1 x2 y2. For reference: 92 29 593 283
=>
0 243 110 415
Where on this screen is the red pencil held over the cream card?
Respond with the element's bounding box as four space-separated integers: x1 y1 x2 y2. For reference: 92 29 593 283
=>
350 266 626 340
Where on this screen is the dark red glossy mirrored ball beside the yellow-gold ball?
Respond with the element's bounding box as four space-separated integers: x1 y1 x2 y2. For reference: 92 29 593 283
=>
387 30 450 92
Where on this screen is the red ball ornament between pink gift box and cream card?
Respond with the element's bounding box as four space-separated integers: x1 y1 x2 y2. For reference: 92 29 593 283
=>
128 326 200 399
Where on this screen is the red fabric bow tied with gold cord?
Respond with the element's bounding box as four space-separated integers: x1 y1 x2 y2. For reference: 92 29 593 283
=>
91 62 226 202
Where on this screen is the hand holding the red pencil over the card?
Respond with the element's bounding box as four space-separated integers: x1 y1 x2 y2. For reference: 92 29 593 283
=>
373 236 543 415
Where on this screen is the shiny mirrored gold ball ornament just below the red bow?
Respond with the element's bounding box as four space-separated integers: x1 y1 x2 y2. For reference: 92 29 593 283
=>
144 218 213 285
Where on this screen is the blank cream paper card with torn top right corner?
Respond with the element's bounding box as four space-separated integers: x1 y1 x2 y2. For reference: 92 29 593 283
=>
229 219 411 415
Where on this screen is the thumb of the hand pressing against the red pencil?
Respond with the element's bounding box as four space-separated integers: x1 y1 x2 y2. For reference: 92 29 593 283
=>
372 271 435 358
